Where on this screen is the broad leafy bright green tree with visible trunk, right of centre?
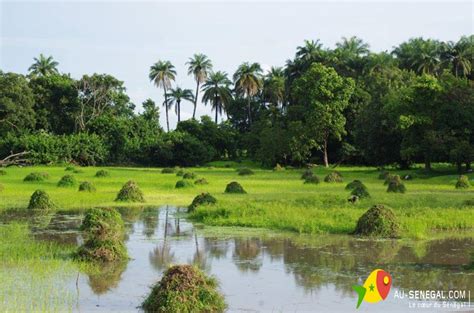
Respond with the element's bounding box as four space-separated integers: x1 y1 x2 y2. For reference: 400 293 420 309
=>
292 63 354 167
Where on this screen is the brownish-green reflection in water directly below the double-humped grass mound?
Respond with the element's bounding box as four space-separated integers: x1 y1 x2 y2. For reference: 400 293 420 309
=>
88 261 128 295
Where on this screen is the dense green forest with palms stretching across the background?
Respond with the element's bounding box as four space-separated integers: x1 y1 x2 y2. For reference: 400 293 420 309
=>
0 35 474 171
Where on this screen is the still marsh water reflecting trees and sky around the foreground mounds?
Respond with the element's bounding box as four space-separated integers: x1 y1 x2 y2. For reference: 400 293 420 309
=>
0 207 474 312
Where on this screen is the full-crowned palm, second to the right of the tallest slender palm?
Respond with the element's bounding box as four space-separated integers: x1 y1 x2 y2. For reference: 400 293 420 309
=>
233 62 263 126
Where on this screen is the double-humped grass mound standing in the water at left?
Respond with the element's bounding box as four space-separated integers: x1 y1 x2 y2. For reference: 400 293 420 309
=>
77 208 127 262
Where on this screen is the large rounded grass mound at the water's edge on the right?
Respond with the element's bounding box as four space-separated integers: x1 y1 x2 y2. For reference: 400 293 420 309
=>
354 204 400 238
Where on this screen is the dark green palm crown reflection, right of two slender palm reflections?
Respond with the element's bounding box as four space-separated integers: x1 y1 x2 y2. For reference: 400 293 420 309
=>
233 238 263 272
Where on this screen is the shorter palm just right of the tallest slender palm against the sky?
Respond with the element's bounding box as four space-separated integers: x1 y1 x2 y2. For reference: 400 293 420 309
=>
202 71 232 124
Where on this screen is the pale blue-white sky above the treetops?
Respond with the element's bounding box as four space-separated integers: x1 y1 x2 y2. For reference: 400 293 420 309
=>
0 0 474 127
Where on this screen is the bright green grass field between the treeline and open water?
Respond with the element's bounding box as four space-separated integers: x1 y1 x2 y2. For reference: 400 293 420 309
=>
0 162 474 238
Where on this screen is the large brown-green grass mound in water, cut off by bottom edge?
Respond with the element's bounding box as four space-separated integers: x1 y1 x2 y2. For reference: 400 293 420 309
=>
142 265 226 313
